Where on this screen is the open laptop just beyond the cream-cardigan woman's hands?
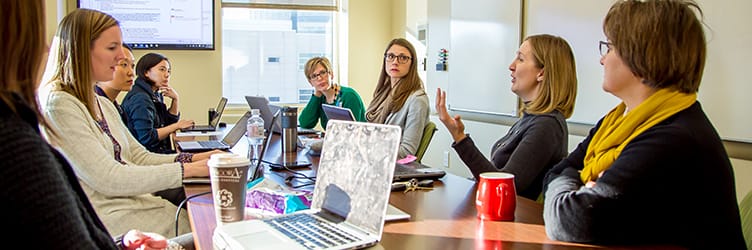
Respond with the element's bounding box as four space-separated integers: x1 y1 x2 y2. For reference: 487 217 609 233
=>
178 111 251 152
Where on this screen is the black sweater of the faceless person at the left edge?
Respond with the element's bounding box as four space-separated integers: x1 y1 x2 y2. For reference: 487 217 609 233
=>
0 95 118 249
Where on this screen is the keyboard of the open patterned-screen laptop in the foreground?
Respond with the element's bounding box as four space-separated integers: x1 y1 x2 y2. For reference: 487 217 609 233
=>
264 213 359 249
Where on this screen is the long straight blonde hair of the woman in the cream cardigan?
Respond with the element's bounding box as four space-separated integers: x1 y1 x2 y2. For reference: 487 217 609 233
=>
50 9 119 120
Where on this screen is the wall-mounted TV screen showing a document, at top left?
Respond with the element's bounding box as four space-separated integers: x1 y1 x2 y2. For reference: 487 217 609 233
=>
77 0 214 50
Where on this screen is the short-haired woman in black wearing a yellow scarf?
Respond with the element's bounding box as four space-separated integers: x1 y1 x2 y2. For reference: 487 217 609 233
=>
543 0 745 249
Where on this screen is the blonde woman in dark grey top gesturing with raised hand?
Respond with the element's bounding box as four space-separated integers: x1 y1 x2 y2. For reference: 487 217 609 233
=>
436 35 577 200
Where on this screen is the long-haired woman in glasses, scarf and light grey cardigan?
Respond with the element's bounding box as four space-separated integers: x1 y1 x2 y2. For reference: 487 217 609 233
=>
366 38 429 158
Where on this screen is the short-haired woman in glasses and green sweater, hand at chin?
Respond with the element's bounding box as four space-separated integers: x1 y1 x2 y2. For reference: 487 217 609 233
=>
298 57 366 128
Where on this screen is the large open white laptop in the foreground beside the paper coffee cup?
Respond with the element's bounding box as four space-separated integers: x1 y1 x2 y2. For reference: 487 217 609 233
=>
212 120 402 249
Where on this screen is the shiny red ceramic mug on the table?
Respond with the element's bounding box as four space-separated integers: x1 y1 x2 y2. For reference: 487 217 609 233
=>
475 172 517 221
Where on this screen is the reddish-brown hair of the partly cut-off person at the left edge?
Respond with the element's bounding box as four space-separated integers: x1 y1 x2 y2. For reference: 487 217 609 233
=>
0 0 47 124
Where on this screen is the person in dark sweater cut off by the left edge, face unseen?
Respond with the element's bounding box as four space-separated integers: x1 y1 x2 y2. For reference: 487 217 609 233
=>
0 0 175 249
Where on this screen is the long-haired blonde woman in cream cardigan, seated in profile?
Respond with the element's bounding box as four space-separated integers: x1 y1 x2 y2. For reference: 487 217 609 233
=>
40 9 214 238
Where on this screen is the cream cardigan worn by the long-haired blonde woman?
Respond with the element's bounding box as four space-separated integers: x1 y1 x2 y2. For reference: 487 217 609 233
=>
41 90 190 236
